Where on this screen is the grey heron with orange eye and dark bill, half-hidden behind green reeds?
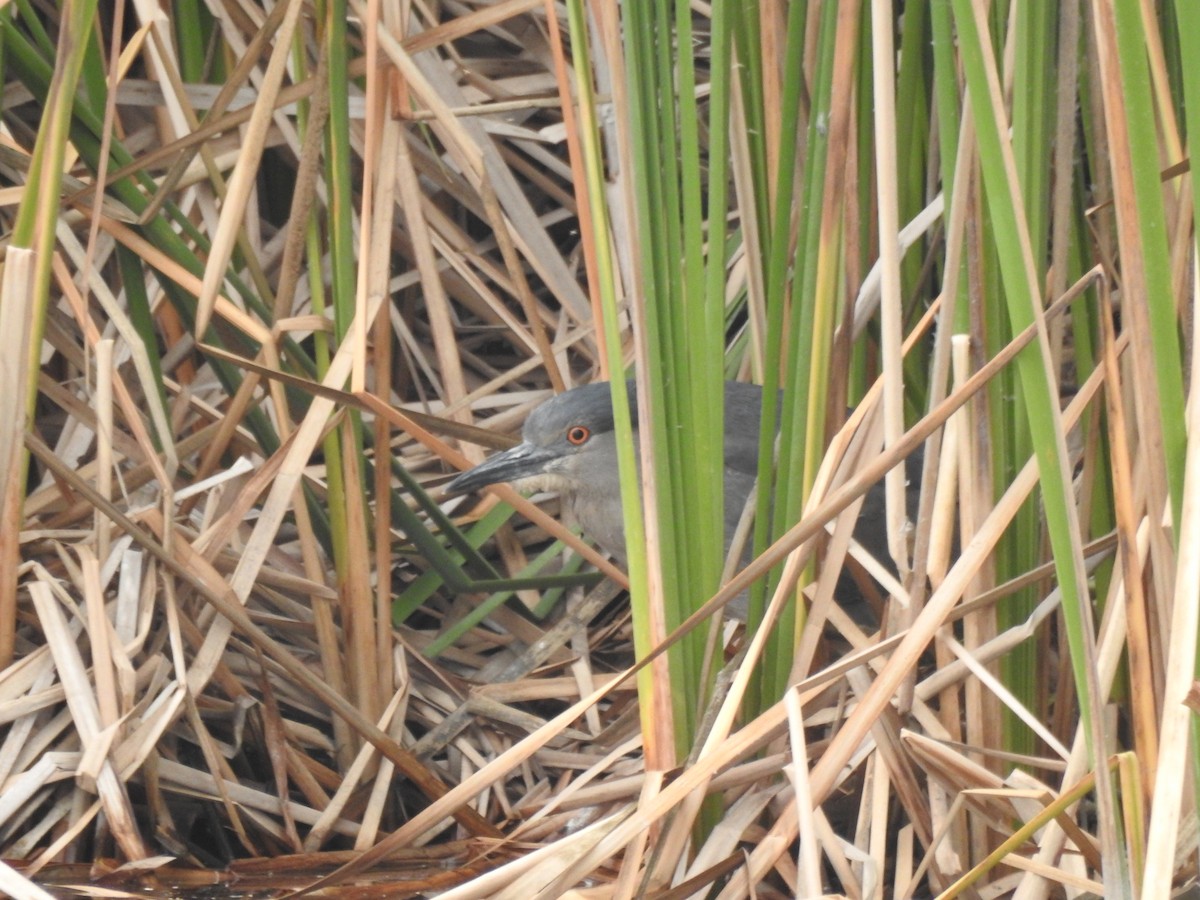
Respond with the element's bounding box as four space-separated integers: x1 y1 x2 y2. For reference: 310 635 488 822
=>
445 380 922 619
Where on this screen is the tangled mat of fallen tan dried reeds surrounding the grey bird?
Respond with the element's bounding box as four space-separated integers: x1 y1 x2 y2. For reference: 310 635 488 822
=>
0 0 1195 898
